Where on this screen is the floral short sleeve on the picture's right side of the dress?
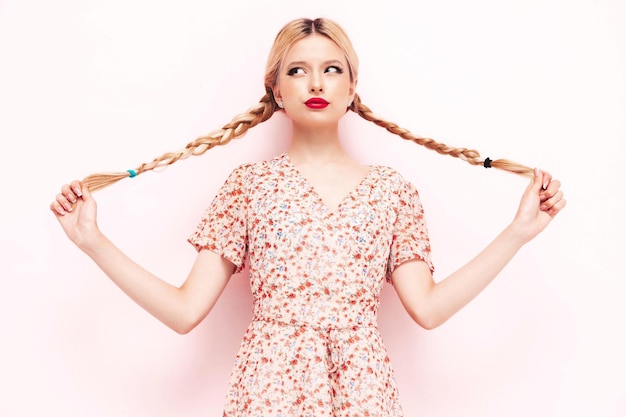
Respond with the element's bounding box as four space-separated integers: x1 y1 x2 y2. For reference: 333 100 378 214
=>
387 181 435 281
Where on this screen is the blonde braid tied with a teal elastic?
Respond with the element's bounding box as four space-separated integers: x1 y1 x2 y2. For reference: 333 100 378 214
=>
83 92 278 191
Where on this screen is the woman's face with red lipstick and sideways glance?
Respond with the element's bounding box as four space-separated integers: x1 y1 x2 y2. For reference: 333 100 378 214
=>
274 34 356 127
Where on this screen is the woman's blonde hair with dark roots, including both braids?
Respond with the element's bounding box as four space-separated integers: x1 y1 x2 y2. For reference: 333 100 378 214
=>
83 18 533 191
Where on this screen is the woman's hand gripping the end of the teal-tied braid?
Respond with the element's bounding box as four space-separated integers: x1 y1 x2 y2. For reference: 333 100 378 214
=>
50 181 99 249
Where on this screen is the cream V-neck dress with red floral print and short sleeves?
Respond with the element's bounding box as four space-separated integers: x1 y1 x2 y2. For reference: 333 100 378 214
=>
189 153 433 417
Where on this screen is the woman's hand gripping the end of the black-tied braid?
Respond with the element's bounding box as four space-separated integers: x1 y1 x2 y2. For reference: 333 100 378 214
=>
513 168 565 240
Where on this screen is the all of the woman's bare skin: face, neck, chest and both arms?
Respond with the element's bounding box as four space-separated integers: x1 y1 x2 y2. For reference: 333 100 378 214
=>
50 35 565 334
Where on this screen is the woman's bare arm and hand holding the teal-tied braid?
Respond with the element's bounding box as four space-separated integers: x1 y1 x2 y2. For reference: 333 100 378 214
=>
50 181 235 334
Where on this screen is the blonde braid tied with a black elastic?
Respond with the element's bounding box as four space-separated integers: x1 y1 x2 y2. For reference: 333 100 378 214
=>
349 94 533 177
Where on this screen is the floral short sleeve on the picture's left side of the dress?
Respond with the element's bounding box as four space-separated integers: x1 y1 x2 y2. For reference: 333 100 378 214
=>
187 165 248 273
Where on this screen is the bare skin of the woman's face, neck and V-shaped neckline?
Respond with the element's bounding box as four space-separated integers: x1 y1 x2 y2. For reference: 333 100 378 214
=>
274 35 369 210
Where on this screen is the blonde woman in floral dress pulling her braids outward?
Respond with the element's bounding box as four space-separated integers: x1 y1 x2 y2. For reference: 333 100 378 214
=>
50 19 565 417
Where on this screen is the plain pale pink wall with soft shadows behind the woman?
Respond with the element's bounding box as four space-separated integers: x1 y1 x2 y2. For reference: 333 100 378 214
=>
0 0 626 417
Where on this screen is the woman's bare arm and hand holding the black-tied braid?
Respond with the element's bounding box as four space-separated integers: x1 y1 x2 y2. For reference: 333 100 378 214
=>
392 170 565 329
